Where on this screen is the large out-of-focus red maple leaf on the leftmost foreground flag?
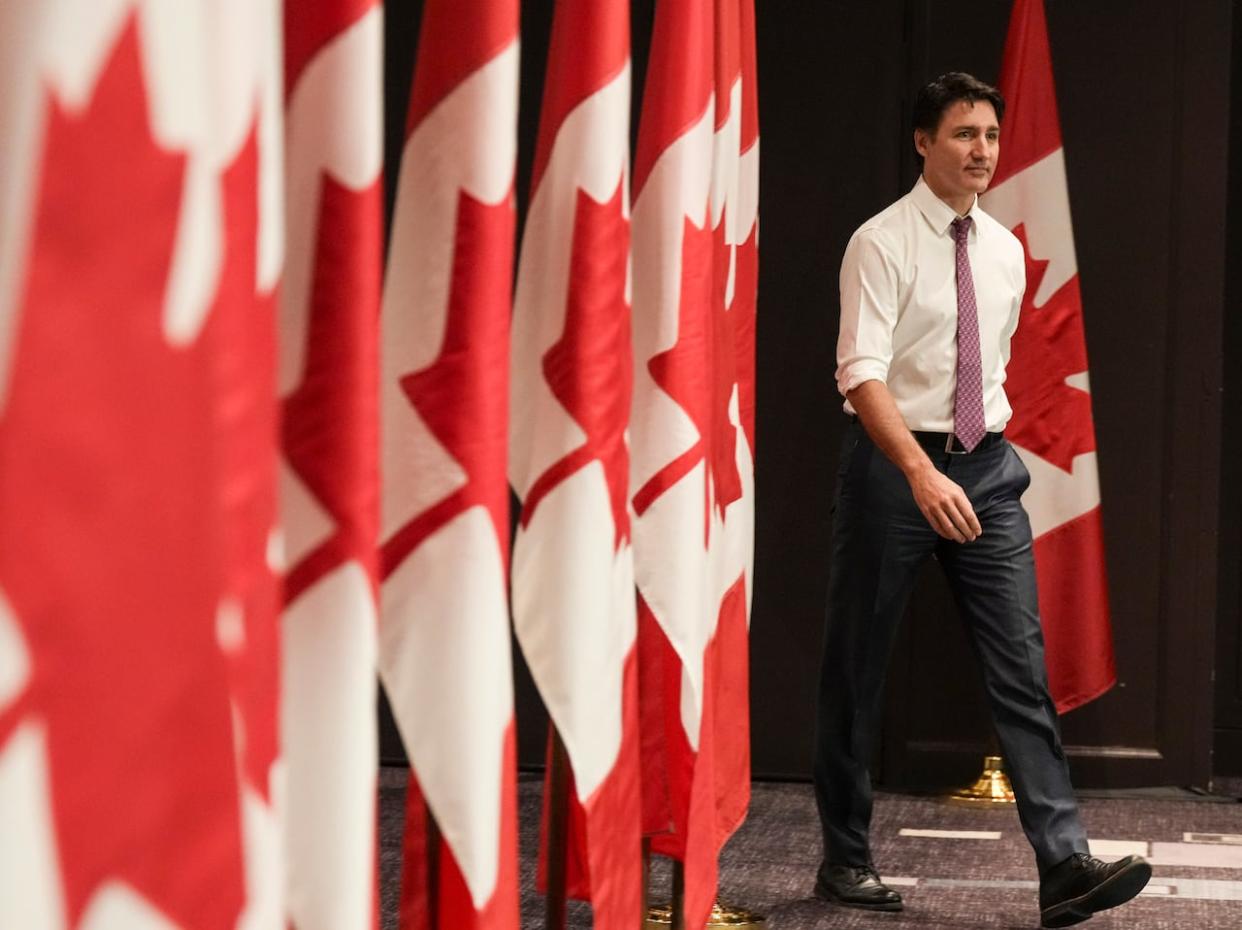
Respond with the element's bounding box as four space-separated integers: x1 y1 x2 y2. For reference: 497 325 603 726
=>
0 21 253 930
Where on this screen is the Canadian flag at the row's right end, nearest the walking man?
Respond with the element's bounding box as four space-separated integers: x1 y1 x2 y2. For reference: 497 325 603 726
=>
632 0 758 928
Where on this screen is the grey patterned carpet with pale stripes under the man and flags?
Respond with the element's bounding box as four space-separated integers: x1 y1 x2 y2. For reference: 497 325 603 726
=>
380 769 1242 930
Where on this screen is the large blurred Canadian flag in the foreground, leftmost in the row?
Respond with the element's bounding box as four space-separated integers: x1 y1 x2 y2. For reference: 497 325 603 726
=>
0 0 284 930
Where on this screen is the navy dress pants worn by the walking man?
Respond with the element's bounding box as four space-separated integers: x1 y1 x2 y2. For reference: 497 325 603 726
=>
815 422 1088 874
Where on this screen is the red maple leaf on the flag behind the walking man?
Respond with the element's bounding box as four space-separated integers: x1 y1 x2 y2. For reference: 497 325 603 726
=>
1005 225 1095 472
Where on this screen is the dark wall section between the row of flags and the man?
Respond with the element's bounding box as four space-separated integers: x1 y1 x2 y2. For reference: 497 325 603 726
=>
735 2 914 777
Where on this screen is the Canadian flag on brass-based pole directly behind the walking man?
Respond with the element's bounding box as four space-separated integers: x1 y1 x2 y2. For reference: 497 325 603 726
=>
981 0 1117 711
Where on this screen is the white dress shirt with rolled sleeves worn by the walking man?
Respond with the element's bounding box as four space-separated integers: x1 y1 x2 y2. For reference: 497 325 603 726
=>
837 178 1026 432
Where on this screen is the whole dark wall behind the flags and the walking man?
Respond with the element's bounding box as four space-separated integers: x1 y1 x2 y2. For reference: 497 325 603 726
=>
385 0 1242 785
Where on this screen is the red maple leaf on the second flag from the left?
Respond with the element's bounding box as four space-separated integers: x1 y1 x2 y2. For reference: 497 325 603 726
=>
281 175 383 602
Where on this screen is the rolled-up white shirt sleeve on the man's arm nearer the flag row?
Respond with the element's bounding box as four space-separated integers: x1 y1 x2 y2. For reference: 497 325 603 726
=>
837 228 898 396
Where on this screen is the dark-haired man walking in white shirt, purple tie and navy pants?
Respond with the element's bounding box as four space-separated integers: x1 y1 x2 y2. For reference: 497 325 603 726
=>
815 72 1151 926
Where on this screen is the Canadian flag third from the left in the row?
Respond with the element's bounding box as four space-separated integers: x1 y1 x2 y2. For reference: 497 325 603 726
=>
380 0 518 930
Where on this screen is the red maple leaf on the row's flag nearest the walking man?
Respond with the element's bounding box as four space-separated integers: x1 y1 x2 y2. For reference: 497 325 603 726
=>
635 217 741 545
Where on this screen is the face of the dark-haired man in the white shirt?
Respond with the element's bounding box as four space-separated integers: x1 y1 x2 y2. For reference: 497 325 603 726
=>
914 101 1001 202
